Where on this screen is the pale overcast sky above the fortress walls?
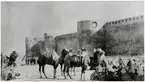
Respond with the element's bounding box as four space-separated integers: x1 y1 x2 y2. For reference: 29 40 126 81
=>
1 1 144 53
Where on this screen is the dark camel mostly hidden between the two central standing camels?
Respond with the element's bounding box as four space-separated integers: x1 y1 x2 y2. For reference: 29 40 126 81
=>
59 48 69 75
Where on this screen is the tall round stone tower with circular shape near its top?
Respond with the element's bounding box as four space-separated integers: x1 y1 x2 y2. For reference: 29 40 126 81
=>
77 20 97 55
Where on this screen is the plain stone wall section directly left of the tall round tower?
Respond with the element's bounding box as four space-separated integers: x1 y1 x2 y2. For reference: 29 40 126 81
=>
55 33 78 55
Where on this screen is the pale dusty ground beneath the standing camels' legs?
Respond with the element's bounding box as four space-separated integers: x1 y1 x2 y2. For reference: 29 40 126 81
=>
10 65 93 81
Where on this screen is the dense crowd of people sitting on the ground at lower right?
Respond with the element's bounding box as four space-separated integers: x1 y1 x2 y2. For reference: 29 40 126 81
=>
90 52 144 81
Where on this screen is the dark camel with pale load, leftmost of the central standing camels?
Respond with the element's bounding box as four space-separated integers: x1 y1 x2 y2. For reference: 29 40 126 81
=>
37 50 59 79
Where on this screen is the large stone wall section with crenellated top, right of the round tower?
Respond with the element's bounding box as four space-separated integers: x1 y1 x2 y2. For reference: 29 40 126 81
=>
104 16 144 55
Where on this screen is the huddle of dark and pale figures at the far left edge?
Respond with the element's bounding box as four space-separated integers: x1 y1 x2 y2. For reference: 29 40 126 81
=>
1 51 20 80
